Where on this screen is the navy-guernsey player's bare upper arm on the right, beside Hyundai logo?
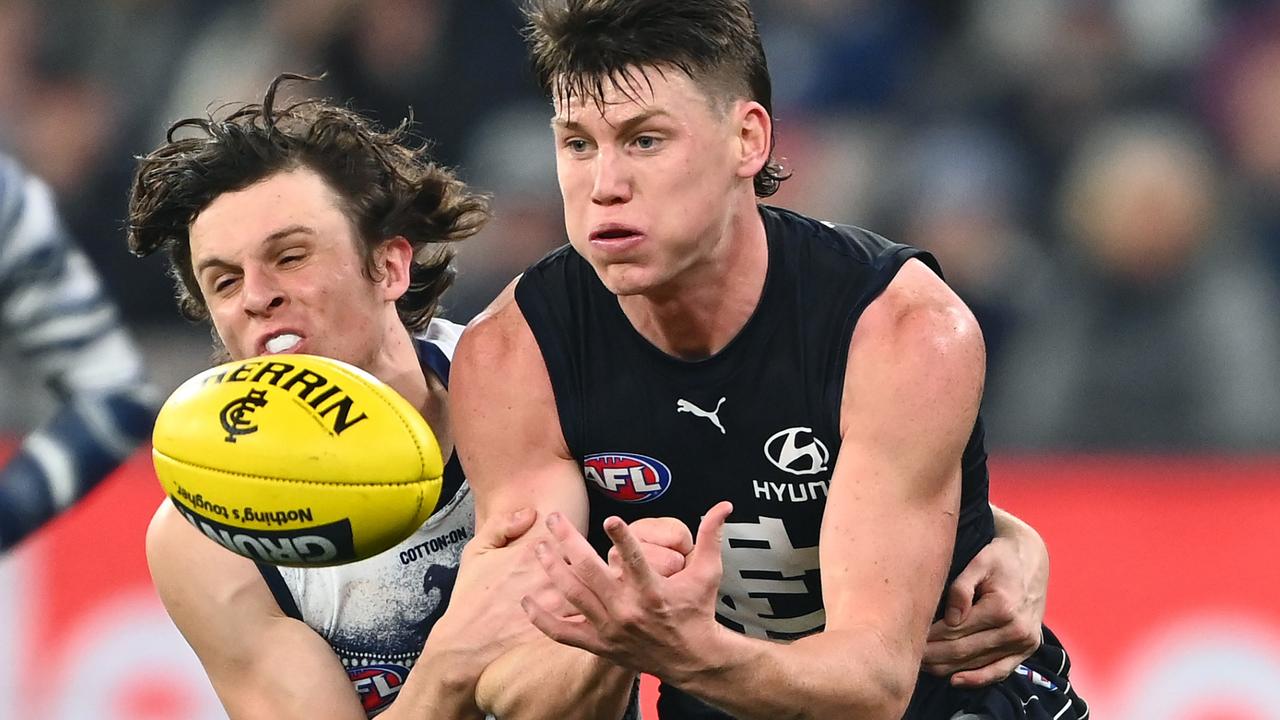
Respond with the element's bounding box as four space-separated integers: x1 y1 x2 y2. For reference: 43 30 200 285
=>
819 263 983 650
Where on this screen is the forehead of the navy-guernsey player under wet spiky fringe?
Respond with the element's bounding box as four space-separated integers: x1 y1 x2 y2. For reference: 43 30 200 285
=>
553 65 712 122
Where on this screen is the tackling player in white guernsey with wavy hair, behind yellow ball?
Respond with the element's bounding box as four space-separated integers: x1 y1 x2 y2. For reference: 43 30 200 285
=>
129 76 691 720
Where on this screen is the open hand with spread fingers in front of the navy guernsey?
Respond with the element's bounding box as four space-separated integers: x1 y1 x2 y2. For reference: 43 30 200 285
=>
521 502 733 678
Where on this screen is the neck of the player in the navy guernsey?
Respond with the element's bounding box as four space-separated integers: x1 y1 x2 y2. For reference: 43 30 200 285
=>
618 196 769 360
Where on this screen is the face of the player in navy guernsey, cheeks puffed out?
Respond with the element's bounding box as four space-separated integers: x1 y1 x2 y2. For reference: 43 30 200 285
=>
552 68 754 295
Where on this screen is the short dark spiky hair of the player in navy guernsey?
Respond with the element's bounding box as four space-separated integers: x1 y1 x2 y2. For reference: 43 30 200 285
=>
524 0 791 197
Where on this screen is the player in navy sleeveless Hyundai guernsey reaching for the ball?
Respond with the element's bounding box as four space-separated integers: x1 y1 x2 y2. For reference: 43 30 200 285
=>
452 0 1088 720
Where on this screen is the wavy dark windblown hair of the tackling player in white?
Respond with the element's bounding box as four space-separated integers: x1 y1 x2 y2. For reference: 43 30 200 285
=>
128 73 489 332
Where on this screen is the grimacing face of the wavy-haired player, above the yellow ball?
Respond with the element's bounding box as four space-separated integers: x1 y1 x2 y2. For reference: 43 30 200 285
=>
191 169 404 370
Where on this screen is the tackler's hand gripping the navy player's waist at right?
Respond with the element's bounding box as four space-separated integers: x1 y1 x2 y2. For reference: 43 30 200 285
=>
923 537 1048 687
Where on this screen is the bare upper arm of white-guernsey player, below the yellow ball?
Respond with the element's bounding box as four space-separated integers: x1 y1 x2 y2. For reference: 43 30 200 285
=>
147 502 365 720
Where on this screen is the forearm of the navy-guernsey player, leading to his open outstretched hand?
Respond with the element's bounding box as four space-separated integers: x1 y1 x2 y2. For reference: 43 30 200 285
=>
660 626 923 720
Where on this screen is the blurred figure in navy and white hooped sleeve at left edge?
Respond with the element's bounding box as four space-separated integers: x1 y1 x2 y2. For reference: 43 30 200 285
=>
0 155 157 551
